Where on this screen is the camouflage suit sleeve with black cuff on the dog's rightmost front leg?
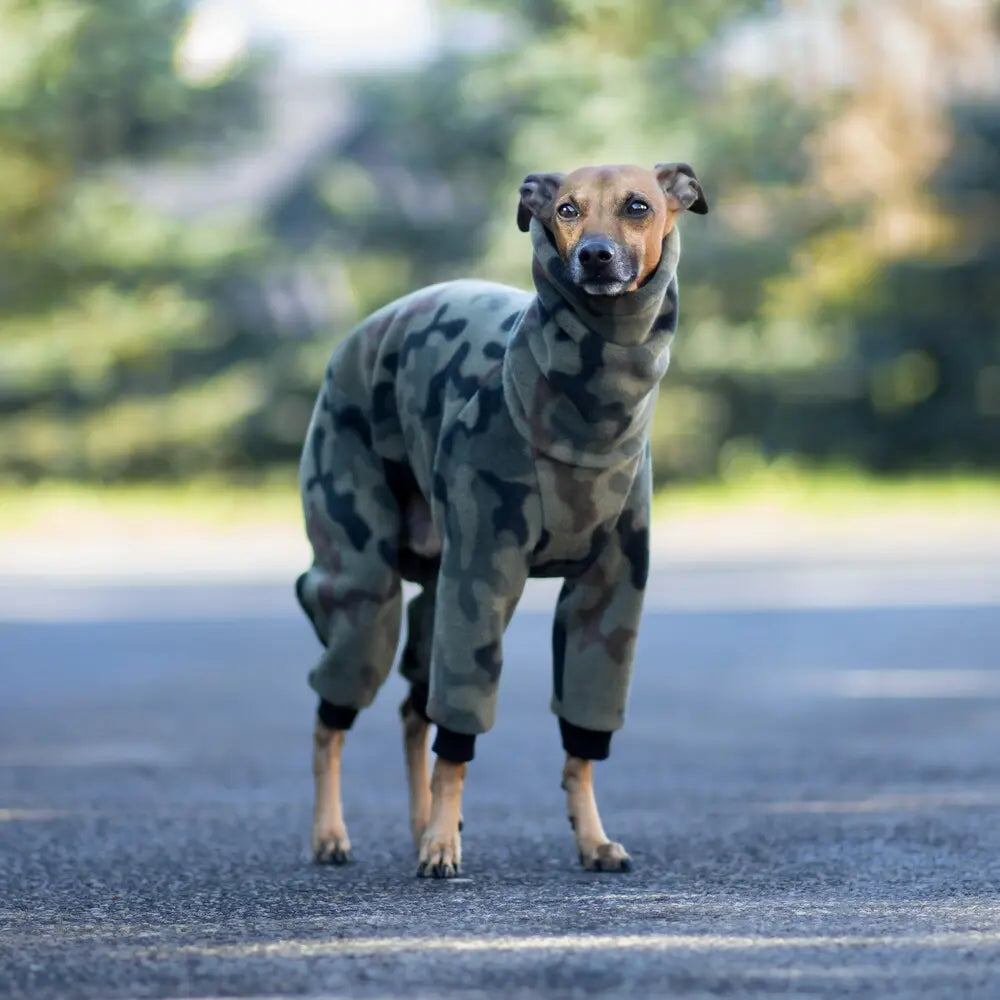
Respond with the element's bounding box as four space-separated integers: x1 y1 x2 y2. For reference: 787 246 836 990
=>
552 448 652 760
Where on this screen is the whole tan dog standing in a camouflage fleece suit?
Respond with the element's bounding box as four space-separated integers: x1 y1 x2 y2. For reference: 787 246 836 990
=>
296 163 708 878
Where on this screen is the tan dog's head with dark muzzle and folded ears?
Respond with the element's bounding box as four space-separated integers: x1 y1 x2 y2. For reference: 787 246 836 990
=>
517 163 708 295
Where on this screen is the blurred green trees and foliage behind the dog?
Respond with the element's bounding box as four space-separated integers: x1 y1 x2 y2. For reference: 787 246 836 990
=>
0 0 1000 484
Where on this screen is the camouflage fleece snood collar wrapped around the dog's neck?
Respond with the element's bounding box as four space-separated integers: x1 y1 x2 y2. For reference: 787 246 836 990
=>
503 220 680 468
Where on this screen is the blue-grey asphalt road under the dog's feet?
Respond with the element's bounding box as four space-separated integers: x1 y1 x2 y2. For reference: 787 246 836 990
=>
0 578 1000 1000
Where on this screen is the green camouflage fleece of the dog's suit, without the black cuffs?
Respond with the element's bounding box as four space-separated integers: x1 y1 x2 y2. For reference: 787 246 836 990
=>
297 220 680 734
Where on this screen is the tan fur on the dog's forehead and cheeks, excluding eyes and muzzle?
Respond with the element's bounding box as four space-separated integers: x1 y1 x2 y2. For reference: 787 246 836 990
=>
550 166 682 292
